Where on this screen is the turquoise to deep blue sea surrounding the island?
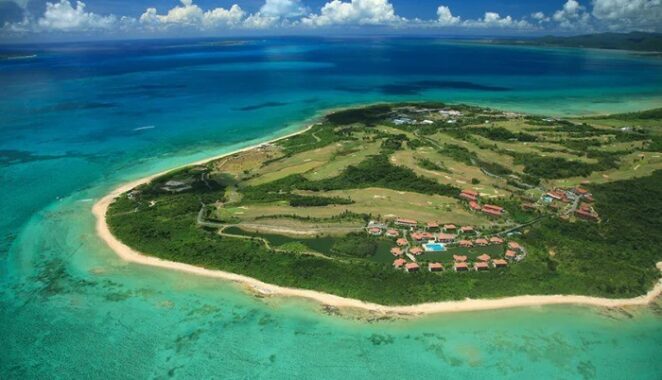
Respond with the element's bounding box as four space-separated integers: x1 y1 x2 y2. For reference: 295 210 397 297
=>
0 38 662 379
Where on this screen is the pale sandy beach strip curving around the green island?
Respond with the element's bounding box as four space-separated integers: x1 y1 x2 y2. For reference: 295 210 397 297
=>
92 125 662 315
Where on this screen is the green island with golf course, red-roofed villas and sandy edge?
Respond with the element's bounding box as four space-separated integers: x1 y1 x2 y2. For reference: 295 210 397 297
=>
94 103 662 312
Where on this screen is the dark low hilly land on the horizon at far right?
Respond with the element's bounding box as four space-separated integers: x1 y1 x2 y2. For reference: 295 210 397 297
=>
489 32 662 52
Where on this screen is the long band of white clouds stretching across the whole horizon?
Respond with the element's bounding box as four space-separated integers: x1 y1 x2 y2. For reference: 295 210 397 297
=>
5 0 662 37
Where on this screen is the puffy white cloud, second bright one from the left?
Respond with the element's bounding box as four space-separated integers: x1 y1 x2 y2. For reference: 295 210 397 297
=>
139 0 246 29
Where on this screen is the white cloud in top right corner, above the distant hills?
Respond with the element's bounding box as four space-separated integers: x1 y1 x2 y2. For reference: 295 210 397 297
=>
592 0 662 30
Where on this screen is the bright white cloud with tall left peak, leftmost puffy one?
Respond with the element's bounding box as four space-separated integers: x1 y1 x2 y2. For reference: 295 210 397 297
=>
37 0 119 31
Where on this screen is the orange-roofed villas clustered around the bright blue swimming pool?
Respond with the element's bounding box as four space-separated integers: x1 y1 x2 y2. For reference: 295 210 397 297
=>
367 218 526 272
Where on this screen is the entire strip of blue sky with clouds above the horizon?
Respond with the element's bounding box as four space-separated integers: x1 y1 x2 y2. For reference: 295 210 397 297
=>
0 0 662 42
